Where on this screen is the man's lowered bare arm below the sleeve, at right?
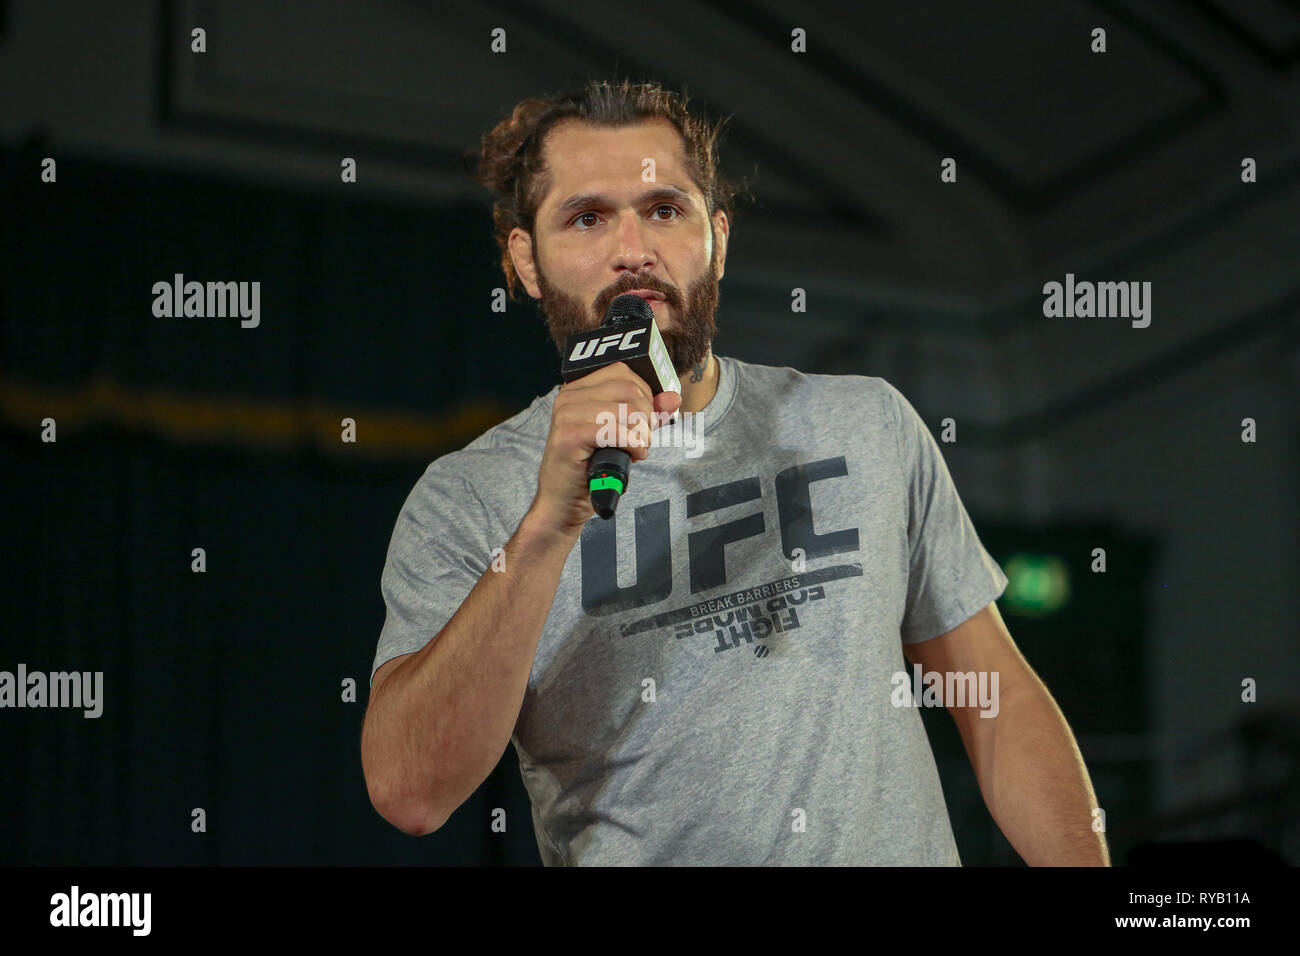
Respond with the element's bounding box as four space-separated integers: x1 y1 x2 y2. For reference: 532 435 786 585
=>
904 604 1110 866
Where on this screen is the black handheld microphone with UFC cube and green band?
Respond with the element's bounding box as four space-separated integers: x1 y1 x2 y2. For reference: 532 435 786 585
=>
560 293 681 519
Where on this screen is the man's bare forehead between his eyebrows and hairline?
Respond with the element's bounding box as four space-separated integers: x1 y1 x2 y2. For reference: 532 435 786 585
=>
542 120 697 207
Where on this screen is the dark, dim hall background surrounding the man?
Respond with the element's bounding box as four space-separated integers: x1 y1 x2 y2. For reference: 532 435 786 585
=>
0 0 1300 865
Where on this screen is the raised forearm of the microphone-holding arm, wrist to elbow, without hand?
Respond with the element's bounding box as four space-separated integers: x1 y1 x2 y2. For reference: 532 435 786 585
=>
361 516 573 832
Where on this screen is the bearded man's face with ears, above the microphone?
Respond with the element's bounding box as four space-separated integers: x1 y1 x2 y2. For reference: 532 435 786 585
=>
510 120 728 375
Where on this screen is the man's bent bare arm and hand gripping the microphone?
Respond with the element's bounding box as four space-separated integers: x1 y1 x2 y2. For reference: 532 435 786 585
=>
361 362 681 835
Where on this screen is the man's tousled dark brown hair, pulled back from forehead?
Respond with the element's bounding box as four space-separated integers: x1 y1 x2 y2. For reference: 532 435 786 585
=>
463 78 749 299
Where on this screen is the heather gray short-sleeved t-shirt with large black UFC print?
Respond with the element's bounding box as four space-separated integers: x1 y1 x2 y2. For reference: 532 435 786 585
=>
372 356 1006 866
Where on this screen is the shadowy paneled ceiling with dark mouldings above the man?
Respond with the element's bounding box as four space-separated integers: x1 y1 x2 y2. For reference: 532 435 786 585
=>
0 0 1300 405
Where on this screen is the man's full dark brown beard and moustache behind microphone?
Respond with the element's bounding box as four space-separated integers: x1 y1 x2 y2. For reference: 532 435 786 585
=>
537 252 718 376
